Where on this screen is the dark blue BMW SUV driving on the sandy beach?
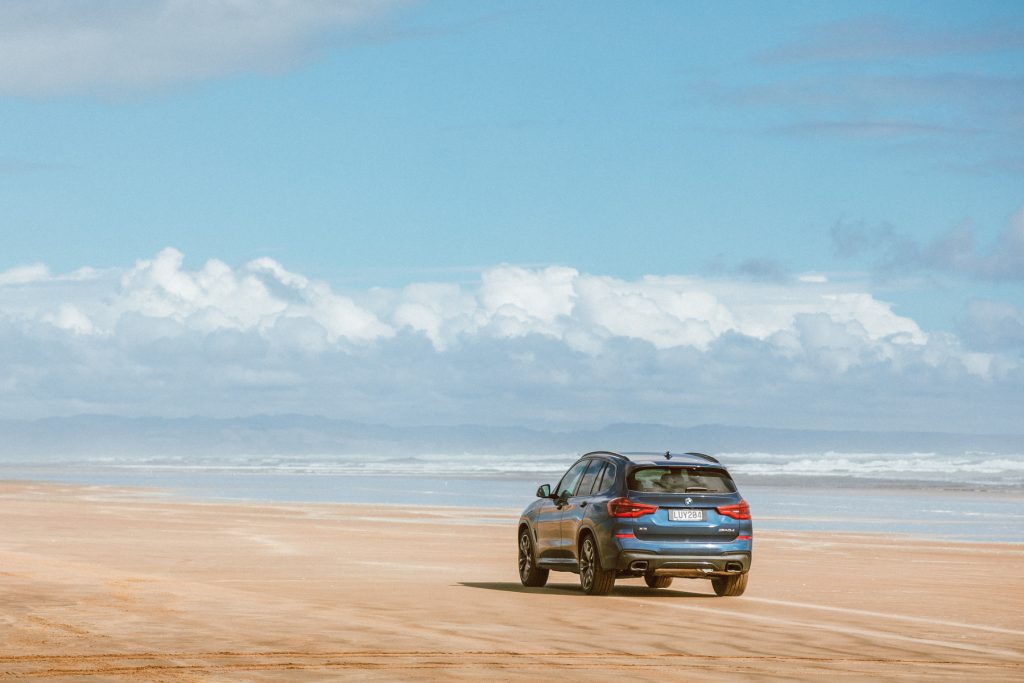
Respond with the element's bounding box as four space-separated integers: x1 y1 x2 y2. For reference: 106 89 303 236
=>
518 451 754 595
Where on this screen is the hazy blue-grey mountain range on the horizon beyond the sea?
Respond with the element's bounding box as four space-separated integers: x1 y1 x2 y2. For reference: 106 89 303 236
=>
0 415 1024 462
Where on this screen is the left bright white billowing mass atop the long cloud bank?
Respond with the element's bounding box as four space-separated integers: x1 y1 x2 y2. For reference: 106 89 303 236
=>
0 248 393 346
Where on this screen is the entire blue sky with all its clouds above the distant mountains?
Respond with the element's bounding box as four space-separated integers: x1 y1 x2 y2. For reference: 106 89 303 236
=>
0 0 1024 431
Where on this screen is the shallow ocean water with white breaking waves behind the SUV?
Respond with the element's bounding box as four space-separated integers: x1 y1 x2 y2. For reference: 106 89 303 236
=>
0 452 1024 543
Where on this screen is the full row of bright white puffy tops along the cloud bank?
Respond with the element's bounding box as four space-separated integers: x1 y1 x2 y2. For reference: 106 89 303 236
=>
0 248 950 354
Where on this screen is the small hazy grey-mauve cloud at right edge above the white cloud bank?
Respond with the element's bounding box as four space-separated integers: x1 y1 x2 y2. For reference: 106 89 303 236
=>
831 209 1024 282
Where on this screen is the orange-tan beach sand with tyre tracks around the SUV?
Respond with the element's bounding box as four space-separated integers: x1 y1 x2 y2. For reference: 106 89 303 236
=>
0 482 1024 681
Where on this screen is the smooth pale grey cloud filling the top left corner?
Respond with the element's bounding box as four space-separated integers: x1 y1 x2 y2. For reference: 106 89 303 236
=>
0 0 396 95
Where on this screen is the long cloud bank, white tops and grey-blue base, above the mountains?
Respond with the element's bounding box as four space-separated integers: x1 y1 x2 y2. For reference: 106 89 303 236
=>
0 249 1021 426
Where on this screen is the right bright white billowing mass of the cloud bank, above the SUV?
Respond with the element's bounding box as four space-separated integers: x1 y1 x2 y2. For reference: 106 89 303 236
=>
376 266 928 354
